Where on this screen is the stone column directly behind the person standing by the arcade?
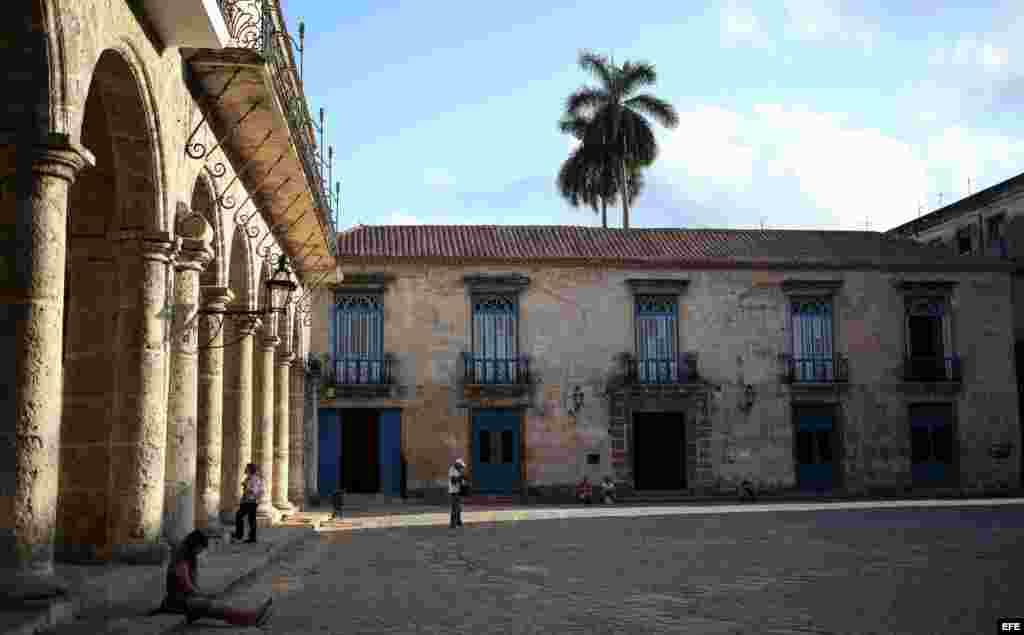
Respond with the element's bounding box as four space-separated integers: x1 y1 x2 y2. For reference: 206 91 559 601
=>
220 319 260 524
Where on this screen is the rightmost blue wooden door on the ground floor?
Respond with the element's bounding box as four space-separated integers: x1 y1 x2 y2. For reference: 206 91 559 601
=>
910 404 953 488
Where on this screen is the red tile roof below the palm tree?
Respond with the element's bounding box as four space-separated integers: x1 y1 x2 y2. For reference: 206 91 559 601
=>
338 225 1012 270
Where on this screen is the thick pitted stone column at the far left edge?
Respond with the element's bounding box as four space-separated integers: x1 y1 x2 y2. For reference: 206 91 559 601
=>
0 135 95 600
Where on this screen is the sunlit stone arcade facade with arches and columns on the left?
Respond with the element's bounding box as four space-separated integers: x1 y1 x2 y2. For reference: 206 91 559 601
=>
0 0 327 596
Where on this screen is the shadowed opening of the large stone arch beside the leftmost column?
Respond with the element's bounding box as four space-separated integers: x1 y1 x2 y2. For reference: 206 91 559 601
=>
55 45 169 561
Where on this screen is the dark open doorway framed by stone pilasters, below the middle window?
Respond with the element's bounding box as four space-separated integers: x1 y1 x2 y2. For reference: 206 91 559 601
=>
633 412 686 490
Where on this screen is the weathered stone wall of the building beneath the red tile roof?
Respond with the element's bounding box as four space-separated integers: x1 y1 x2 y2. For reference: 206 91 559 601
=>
310 262 1020 493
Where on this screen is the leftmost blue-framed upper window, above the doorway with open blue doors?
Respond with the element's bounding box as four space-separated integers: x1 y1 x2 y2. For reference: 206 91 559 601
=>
335 294 384 384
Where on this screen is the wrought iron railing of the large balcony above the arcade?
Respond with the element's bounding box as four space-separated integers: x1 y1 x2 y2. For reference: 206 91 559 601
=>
217 0 338 257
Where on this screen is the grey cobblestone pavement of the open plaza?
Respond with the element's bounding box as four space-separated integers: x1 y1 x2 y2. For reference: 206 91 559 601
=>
161 505 1024 635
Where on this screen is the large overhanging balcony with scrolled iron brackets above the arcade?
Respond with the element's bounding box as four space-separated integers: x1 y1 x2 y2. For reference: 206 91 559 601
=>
184 0 340 284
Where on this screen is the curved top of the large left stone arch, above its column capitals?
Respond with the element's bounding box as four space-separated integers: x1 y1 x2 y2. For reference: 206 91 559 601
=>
74 40 166 234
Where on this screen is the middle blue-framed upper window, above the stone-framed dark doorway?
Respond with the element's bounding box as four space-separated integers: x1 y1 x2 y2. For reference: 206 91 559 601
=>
636 295 679 383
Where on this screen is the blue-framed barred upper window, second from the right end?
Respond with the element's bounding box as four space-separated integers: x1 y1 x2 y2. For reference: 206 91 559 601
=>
791 298 836 382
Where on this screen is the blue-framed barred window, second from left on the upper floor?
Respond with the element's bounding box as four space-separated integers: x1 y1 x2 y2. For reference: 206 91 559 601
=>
470 294 517 384
